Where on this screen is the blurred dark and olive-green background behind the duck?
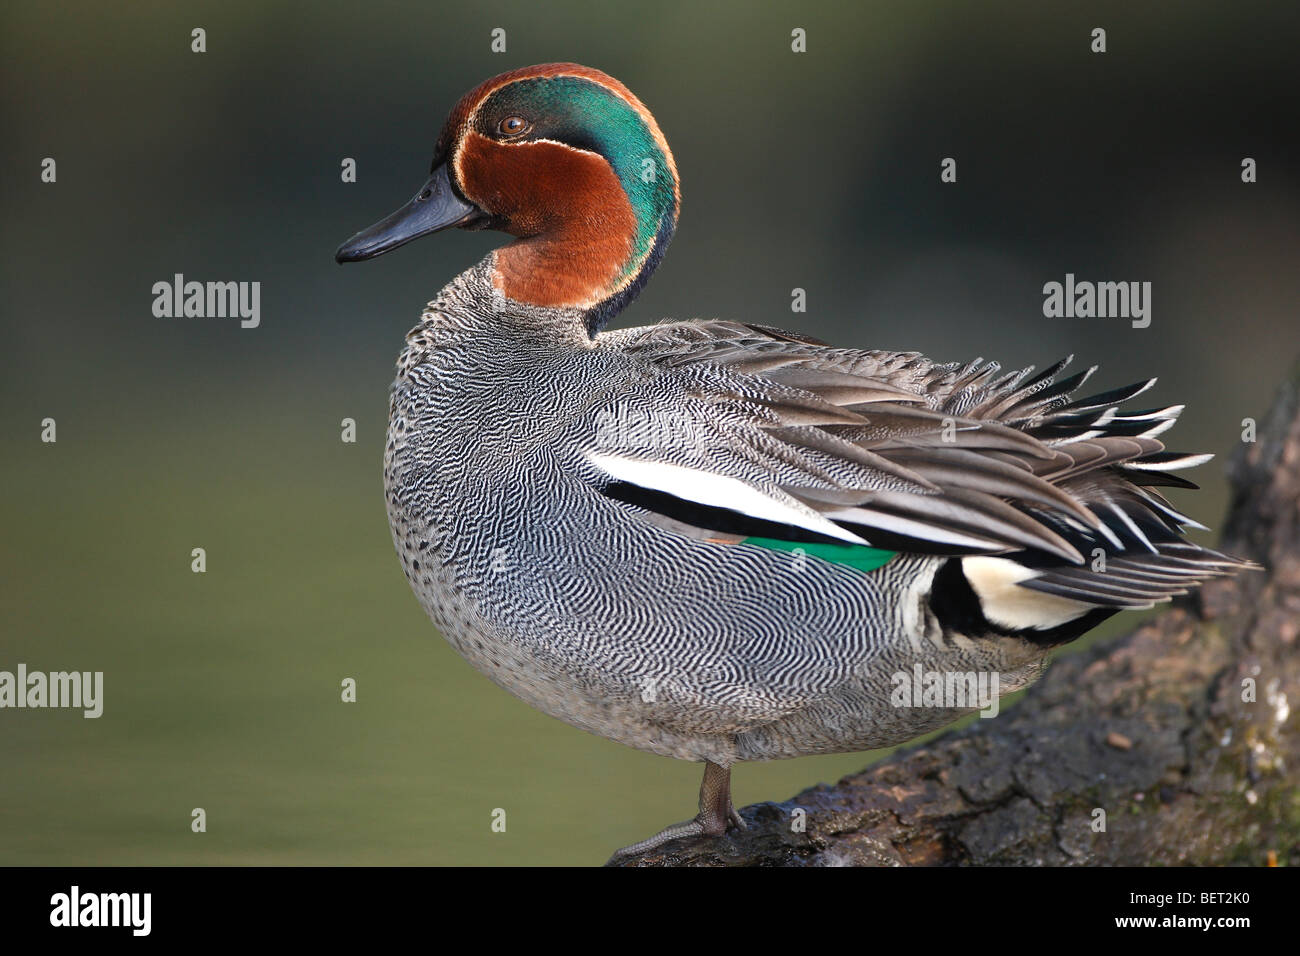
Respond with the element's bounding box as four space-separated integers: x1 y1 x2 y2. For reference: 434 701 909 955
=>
0 1 1300 864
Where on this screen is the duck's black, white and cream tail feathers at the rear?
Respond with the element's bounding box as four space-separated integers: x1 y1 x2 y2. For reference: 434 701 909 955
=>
932 367 1258 645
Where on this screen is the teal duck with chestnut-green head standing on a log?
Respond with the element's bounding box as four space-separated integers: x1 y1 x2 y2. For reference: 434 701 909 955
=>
335 62 1251 860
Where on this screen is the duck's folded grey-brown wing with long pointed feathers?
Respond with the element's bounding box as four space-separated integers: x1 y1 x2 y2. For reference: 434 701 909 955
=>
588 321 1244 607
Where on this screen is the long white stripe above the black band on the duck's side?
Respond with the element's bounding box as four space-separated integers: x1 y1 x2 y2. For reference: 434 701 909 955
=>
588 453 866 545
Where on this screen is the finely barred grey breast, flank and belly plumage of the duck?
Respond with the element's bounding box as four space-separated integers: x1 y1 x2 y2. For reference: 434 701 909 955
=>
385 265 1041 766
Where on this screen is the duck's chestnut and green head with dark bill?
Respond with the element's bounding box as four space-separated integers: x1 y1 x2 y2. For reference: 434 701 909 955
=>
334 62 681 337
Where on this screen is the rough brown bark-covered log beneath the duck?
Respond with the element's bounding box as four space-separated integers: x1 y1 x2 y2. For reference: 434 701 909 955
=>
620 367 1300 866
